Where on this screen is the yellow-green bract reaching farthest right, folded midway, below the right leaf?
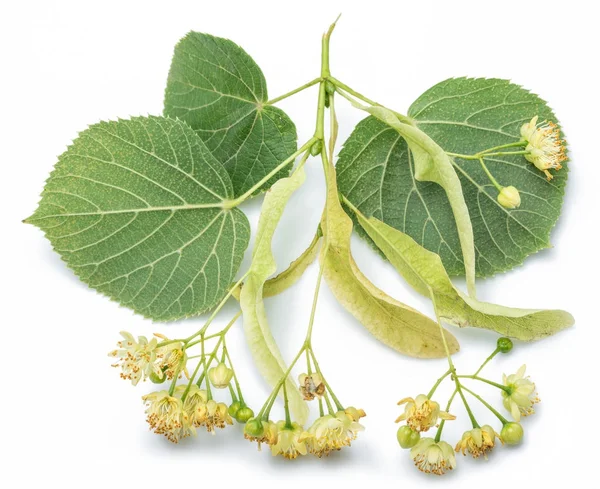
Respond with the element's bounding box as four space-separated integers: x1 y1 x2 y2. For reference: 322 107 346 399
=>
357 212 574 341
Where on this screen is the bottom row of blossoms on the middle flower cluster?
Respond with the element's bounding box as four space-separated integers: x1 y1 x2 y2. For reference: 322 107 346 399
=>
244 407 365 459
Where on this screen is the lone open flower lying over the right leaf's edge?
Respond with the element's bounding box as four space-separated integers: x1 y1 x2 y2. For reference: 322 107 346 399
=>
521 115 567 180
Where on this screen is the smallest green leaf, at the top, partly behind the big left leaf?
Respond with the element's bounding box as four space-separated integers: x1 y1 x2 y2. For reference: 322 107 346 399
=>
164 32 296 197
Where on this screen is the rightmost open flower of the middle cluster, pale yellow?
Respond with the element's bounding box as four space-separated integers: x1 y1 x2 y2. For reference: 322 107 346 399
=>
300 411 364 458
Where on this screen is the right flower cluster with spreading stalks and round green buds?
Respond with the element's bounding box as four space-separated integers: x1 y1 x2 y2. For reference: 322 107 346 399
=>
396 338 539 475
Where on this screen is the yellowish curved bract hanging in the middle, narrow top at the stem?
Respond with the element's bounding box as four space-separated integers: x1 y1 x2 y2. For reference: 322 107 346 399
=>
320 154 459 358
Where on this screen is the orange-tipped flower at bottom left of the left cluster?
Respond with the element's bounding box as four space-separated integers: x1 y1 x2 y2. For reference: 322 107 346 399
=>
142 391 190 443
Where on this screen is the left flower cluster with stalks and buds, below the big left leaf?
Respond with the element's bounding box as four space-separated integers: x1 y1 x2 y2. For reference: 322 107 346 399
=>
109 323 254 443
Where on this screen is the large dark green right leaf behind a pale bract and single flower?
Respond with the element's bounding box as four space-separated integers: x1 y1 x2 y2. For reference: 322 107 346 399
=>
337 78 567 276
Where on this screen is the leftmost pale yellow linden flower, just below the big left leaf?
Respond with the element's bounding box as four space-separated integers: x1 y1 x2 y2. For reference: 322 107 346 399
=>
108 331 162 385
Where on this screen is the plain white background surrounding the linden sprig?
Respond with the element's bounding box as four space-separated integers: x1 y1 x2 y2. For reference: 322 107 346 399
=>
0 0 600 488
